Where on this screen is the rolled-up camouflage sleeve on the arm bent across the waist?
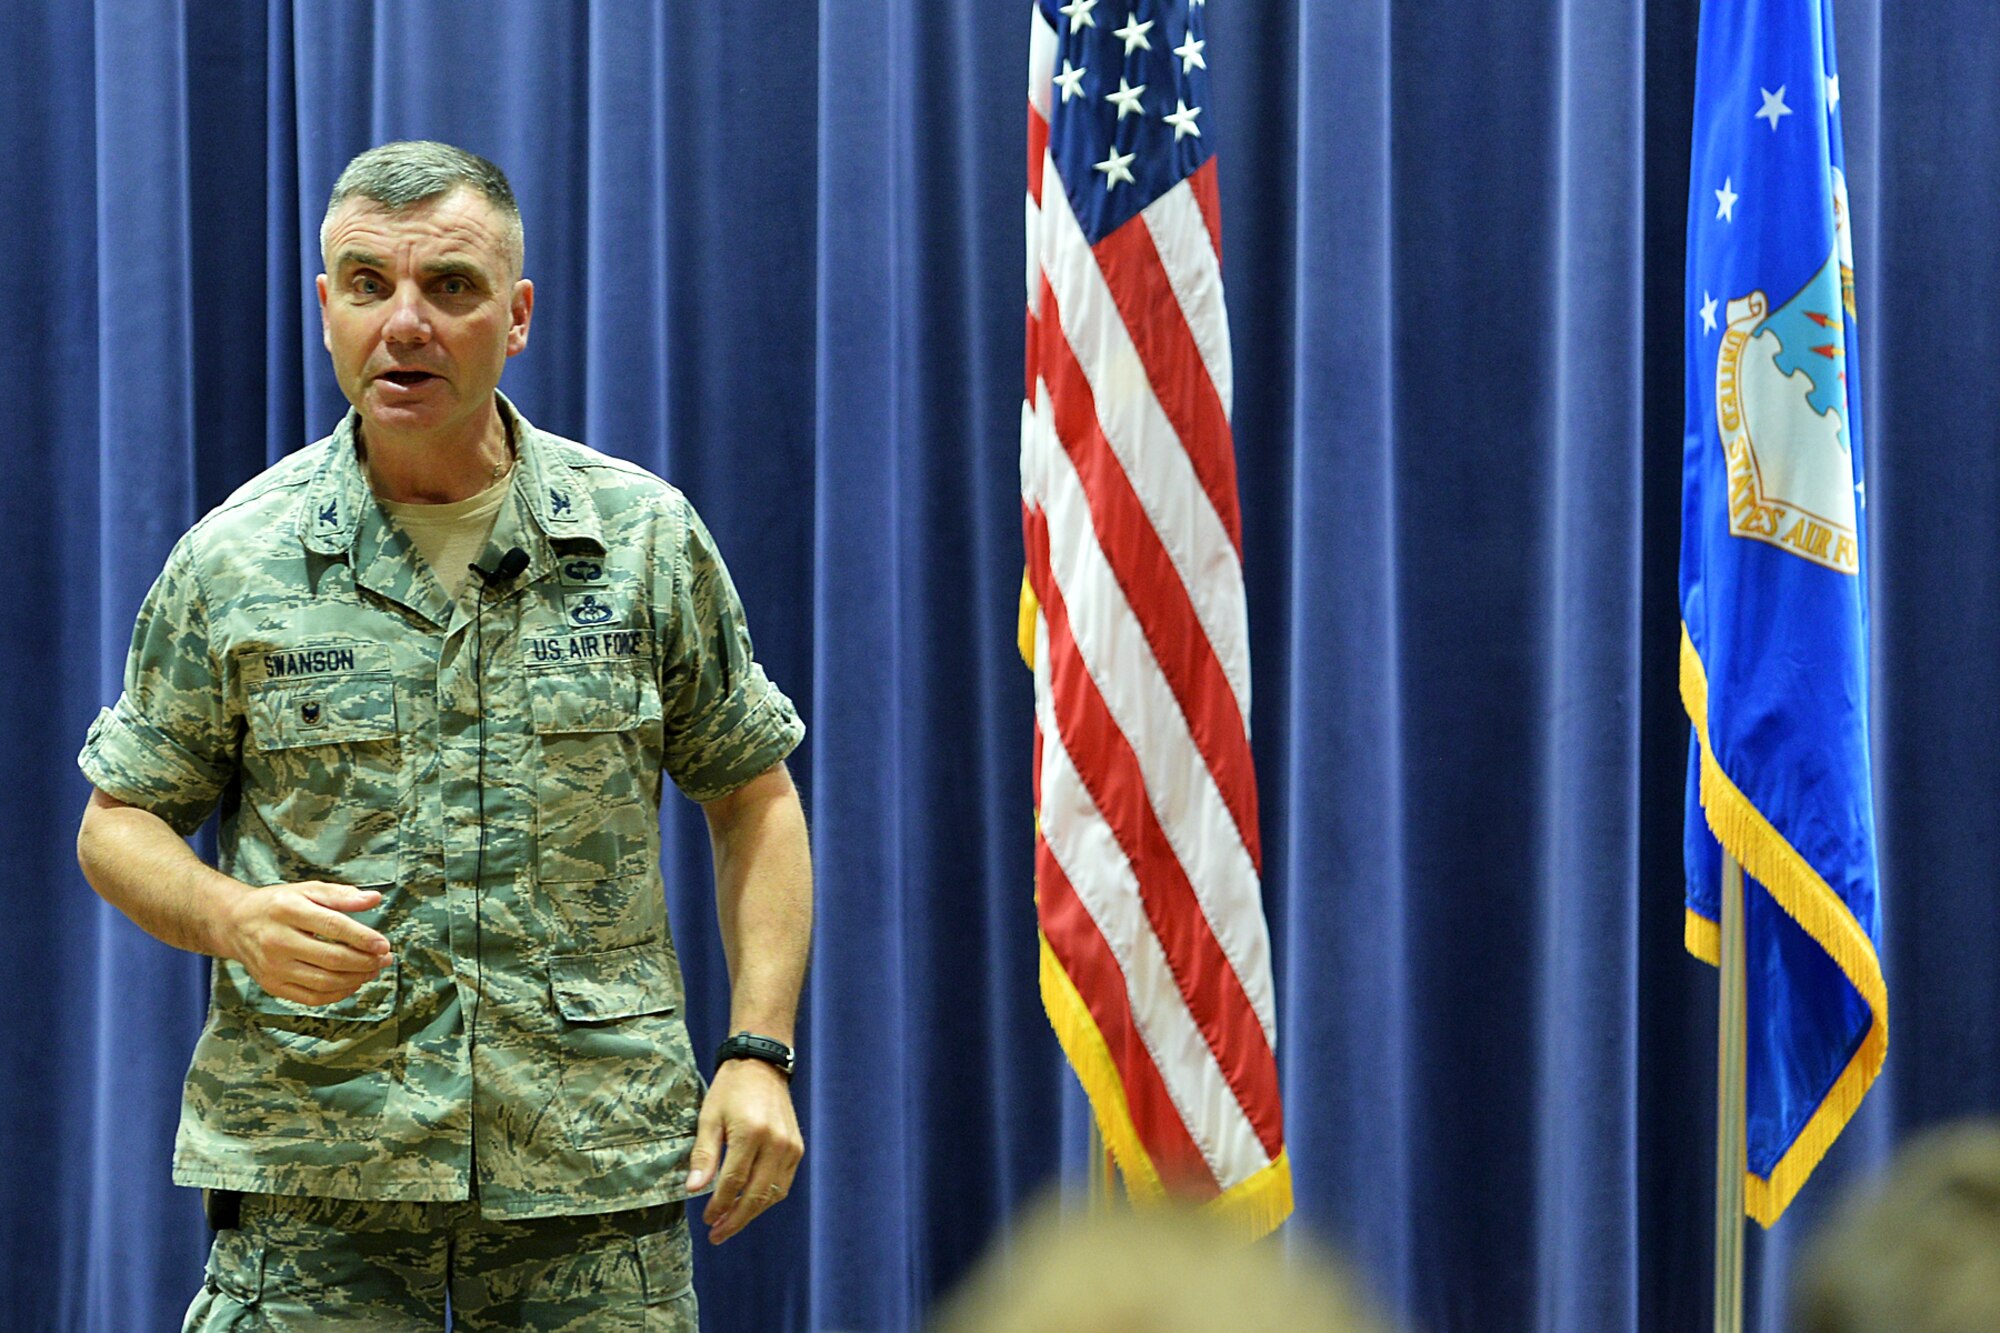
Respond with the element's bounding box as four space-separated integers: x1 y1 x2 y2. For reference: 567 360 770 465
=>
76 534 236 835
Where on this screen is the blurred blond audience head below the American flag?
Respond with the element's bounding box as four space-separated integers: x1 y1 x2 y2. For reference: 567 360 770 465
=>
932 1201 1388 1333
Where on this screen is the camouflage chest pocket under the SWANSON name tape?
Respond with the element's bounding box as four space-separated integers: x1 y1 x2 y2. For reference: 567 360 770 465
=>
244 671 404 885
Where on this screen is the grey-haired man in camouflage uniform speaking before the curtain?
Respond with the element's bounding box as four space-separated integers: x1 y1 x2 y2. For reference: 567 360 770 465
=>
78 144 812 1329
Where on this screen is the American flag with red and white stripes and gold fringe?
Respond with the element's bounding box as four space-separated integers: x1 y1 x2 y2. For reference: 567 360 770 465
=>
1020 0 1292 1235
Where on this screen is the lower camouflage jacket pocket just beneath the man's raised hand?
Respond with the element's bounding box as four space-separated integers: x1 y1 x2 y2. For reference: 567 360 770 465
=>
213 959 402 1139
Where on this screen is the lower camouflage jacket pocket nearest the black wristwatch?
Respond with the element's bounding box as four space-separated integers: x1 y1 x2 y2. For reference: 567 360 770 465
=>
548 945 700 1149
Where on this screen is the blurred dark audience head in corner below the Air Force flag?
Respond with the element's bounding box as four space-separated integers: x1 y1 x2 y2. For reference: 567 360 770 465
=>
1792 1121 2000 1333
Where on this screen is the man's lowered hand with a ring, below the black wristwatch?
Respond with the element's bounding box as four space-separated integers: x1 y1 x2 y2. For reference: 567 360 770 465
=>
688 1059 806 1245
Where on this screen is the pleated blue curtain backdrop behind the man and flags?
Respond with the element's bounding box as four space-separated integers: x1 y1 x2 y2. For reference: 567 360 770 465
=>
0 0 2000 1333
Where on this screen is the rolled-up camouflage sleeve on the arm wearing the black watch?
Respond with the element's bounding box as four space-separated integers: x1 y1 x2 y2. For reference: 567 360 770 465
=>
660 504 806 801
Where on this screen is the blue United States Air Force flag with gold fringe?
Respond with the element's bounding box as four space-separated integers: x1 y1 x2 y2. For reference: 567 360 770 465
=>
1680 0 1888 1227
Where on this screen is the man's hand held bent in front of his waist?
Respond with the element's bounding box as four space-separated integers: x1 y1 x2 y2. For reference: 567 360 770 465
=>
224 881 390 1005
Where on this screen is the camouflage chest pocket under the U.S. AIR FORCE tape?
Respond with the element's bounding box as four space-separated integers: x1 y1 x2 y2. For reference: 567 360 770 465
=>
528 658 662 883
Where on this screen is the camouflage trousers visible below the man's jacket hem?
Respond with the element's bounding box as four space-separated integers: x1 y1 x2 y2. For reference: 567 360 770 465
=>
182 1195 696 1333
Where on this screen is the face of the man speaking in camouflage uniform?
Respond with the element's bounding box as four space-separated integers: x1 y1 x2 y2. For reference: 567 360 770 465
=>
318 190 534 444
